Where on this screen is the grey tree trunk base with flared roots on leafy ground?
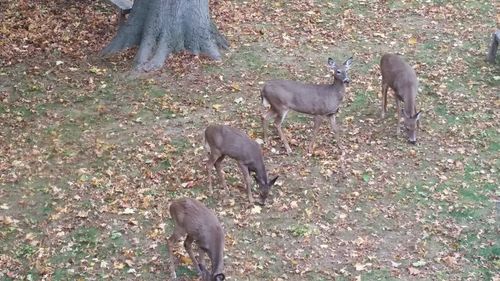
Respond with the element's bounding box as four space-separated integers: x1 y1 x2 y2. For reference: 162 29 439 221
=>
101 0 228 71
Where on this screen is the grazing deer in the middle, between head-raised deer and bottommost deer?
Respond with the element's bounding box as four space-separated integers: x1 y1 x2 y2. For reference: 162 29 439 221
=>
204 124 278 205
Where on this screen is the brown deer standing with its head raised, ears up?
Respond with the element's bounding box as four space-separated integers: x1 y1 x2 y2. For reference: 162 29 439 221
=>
261 57 352 154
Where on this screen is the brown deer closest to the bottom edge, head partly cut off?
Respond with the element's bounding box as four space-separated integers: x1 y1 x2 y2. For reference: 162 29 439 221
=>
167 198 226 281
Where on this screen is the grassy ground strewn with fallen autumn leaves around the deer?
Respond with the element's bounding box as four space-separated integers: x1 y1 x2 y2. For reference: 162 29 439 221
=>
0 0 500 280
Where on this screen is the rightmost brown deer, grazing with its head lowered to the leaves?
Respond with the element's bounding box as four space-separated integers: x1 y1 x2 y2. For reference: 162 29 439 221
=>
380 54 422 144
